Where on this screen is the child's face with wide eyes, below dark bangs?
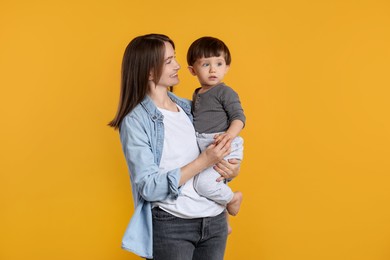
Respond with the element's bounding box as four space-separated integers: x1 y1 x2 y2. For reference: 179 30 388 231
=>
188 55 229 87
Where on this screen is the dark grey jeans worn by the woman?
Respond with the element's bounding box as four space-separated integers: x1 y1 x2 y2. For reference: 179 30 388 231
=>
152 207 227 260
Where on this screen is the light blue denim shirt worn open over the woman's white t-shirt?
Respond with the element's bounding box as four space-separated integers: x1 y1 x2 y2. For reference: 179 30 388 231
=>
119 92 192 258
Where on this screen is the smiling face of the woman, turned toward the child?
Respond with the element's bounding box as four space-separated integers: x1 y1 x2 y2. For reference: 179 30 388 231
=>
157 42 180 88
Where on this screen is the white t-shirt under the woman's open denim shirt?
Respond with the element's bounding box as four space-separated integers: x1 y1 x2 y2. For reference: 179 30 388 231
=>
153 106 225 218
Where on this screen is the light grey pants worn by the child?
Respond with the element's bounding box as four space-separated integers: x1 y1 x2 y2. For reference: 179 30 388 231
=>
194 133 244 205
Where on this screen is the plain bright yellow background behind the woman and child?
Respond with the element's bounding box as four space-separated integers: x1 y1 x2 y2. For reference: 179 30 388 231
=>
0 0 390 260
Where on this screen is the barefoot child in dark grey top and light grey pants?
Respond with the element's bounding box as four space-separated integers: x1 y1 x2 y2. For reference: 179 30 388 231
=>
187 37 245 233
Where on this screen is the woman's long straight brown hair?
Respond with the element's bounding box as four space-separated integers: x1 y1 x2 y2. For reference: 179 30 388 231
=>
108 34 175 129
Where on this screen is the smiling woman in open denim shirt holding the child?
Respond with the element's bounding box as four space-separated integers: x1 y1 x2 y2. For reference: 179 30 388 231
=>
110 34 239 260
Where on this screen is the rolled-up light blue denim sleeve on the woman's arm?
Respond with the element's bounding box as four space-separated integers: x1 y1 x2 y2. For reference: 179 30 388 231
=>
120 115 180 203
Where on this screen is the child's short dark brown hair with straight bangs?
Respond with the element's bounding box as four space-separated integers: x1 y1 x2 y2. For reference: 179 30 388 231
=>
187 36 232 66
